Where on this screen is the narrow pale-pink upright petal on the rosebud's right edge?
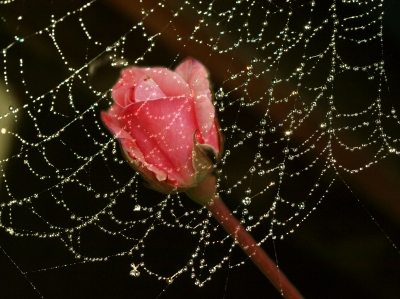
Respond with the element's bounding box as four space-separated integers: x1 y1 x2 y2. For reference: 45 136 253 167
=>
175 58 215 139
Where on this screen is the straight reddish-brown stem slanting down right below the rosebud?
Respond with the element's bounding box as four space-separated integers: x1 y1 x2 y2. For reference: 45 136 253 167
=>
206 197 303 299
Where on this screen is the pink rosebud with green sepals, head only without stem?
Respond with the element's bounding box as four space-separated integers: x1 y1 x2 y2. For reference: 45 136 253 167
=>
101 58 221 193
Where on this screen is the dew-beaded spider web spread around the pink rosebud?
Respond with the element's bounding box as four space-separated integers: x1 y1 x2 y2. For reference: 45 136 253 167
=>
0 0 400 296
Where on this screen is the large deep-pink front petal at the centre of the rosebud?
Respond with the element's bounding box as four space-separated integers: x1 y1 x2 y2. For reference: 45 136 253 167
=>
122 97 198 186
